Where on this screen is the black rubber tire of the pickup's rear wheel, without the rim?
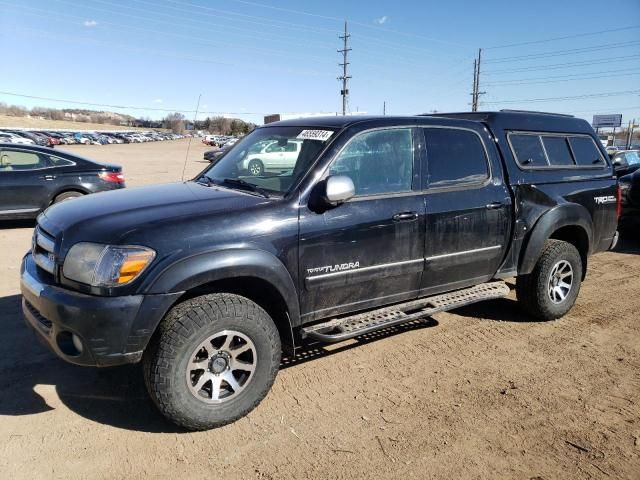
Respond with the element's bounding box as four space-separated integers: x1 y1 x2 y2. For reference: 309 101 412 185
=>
516 240 582 321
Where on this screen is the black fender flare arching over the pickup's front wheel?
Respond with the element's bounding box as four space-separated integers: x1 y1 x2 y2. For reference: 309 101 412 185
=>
144 249 300 327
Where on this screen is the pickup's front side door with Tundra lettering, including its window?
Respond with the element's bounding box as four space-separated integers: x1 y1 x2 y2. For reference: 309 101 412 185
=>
299 128 425 322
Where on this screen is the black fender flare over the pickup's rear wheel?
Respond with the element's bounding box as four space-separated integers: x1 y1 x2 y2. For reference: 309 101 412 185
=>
518 203 593 275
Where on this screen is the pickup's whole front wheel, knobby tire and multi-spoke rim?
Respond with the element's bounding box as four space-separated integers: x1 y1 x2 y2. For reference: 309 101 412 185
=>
143 294 281 430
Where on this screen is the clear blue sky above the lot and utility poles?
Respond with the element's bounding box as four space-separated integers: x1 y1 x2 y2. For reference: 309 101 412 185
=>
0 0 640 123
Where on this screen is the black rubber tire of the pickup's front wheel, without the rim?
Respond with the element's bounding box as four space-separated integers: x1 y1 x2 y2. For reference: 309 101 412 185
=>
143 293 281 430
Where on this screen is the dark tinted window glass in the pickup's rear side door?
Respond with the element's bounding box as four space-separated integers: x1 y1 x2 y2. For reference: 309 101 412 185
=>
424 128 489 187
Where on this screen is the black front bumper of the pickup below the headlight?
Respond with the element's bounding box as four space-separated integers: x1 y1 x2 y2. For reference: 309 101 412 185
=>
20 253 181 367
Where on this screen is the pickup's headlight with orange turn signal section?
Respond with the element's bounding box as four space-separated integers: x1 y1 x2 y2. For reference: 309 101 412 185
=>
62 242 156 287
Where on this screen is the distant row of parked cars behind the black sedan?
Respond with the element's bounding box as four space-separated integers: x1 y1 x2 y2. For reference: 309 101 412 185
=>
0 129 189 147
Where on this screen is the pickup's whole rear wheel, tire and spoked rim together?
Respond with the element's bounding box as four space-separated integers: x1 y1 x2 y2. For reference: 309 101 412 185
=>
516 240 582 320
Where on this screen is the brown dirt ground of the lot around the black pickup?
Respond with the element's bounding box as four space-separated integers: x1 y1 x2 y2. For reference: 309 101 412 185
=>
0 141 640 479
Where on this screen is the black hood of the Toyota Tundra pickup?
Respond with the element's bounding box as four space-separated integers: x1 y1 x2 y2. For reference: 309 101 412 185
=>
38 182 273 243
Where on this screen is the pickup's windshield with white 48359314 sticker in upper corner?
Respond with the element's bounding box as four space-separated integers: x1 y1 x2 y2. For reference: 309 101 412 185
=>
196 127 335 194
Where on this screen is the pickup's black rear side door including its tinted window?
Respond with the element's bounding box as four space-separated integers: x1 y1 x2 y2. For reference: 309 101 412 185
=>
420 122 511 295
